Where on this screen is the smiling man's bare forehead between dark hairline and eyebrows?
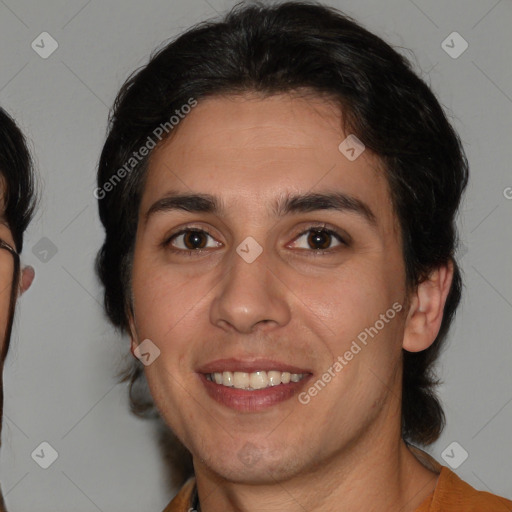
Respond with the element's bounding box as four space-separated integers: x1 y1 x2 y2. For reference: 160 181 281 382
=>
141 94 391 224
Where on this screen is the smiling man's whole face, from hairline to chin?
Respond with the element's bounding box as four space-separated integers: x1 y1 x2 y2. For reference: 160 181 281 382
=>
132 95 405 482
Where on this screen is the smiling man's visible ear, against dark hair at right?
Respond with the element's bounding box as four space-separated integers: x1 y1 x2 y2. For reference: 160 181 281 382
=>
402 260 453 352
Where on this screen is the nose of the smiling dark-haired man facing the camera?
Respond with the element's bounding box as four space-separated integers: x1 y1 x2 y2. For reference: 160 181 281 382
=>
210 242 290 333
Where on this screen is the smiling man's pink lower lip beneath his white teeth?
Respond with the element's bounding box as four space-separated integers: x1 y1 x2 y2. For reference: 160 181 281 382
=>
199 373 311 412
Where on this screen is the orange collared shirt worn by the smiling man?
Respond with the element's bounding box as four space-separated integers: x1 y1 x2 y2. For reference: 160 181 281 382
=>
164 446 512 512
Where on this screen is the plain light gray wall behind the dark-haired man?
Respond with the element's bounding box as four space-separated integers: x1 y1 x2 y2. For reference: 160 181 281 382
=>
0 0 512 512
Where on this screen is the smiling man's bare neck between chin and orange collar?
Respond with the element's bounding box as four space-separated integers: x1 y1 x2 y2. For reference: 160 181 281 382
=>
194 424 439 512
